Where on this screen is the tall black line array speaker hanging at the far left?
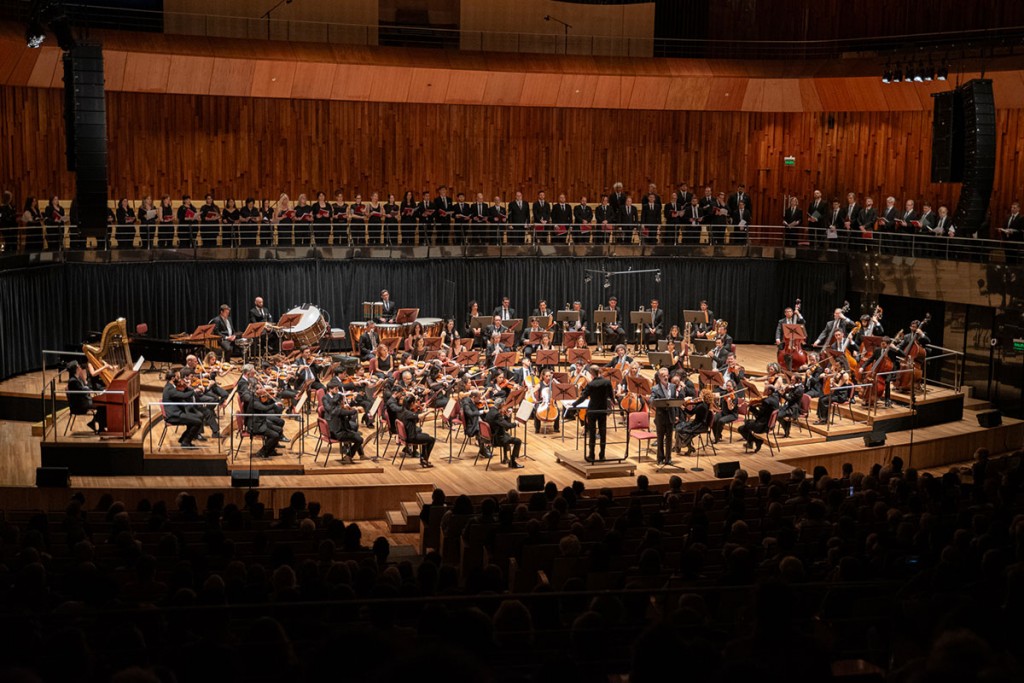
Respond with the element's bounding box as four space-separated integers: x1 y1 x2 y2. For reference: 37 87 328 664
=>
63 44 106 238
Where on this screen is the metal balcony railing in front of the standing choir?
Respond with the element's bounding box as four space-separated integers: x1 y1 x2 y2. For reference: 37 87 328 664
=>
0 221 1024 265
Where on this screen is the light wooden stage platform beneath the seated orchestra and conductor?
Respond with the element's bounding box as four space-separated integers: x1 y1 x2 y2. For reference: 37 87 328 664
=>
0 346 1024 520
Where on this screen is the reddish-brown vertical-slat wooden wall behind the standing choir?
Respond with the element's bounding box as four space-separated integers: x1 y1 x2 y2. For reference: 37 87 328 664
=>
0 87 1024 239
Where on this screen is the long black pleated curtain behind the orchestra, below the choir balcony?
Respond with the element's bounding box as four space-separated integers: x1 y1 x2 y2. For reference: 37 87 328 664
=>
0 258 848 378
